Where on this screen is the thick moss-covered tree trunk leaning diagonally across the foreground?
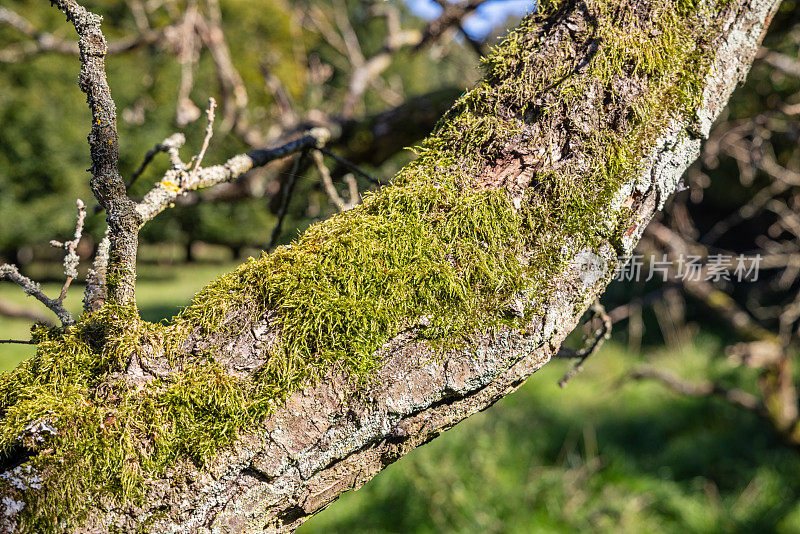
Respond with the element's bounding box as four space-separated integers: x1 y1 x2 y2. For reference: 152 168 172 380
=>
0 0 779 532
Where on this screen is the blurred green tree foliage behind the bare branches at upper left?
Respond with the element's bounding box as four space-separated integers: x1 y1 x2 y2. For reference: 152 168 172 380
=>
0 0 477 261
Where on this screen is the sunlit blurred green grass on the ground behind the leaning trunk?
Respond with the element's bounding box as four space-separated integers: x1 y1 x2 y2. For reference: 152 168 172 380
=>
0 263 800 534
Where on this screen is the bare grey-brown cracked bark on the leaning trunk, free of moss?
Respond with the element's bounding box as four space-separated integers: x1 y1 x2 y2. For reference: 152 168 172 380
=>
0 0 779 533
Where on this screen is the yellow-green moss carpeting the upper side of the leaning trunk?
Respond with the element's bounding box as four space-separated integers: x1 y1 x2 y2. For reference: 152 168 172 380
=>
0 0 736 531
